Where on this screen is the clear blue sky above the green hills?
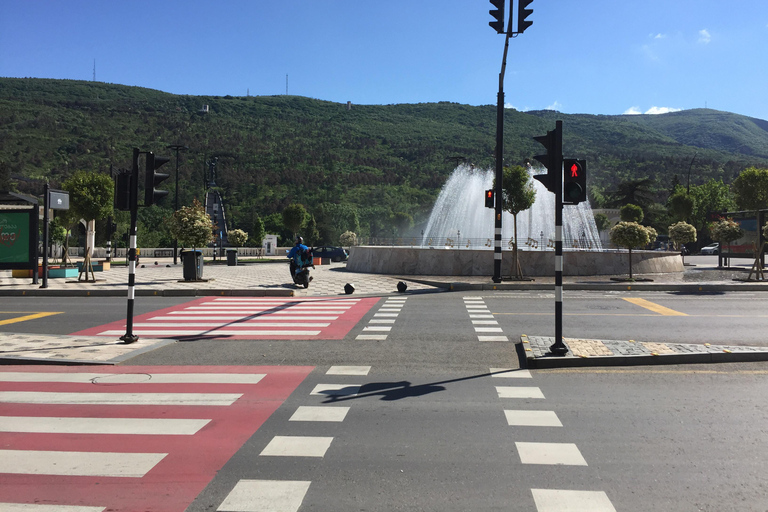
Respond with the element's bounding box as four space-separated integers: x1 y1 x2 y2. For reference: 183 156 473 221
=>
0 0 768 119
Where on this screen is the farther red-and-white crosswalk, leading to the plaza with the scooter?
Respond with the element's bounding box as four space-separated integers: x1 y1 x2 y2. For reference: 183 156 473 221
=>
74 297 378 340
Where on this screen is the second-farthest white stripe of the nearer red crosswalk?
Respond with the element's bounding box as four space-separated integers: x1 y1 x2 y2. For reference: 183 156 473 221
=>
0 391 243 406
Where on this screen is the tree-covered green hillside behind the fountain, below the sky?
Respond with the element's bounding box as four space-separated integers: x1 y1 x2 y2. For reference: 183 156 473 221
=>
0 78 768 242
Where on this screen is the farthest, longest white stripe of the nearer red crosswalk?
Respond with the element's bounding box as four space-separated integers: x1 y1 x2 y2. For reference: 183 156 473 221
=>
0 371 266 384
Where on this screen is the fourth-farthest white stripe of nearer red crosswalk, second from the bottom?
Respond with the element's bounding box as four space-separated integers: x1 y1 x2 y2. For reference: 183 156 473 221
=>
0 450 168 478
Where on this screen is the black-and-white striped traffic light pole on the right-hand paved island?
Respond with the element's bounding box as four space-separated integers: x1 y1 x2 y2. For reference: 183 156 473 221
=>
533 121 568 356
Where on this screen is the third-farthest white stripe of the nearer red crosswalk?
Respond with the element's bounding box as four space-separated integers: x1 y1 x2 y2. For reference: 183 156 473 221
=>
0 416 211 436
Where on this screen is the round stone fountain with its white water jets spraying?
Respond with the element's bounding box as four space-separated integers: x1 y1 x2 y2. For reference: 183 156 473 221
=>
347 165 683 276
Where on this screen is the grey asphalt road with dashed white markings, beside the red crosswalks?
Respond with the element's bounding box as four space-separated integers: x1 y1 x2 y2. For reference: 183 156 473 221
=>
0 292 768 512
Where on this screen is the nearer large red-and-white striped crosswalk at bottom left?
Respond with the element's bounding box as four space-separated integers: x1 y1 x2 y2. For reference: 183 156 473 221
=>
0 366 312 512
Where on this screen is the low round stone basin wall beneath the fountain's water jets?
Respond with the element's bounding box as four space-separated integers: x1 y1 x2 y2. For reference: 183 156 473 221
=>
347 246 684 276
